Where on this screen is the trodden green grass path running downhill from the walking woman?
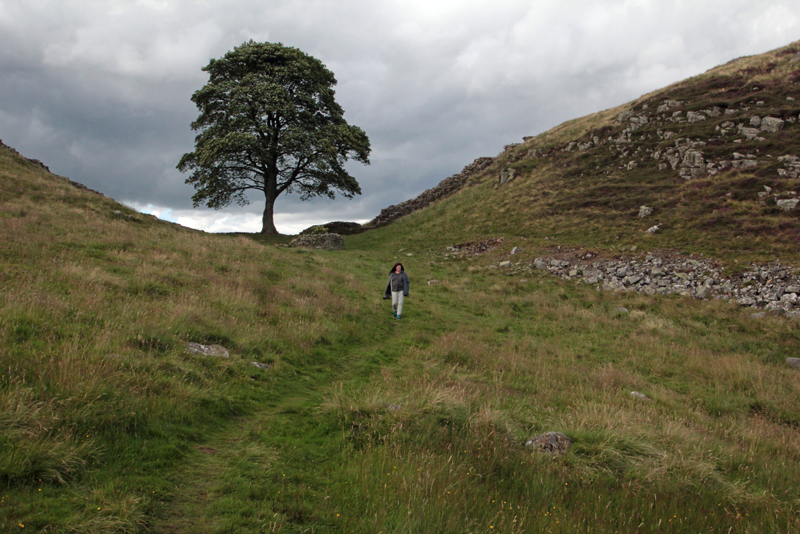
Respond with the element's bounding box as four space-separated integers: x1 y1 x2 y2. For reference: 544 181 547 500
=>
150 262 418 534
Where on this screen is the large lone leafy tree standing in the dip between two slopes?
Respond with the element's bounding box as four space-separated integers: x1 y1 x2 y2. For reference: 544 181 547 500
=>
178 41 370 234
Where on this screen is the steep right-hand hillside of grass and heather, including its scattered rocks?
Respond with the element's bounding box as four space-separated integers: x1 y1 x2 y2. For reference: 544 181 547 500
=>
375 42 800 261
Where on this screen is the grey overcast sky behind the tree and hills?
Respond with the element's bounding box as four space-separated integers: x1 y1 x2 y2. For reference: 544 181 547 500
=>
0 0 800 233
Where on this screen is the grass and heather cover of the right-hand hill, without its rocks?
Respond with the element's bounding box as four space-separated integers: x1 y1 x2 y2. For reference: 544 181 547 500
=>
406 43 800 264
